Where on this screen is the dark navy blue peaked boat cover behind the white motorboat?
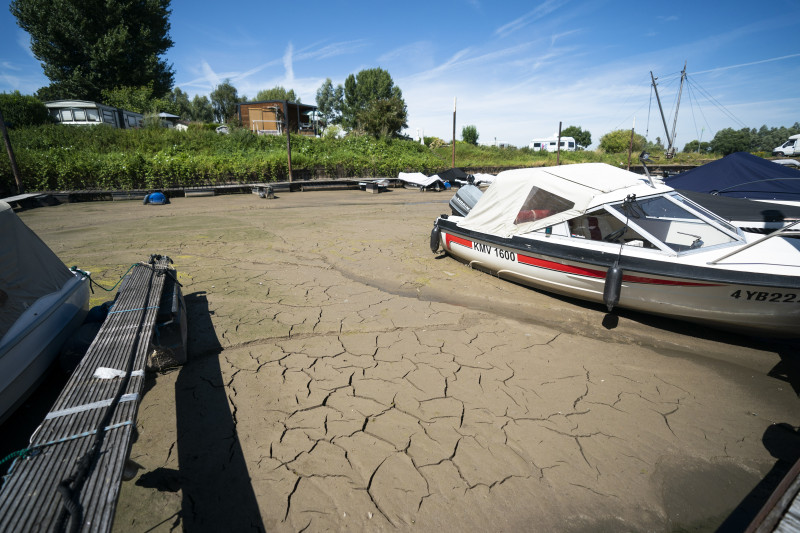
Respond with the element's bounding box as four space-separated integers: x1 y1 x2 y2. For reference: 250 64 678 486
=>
664 152 800 201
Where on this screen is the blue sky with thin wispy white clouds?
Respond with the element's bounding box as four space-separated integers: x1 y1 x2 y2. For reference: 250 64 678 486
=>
0 0 800 149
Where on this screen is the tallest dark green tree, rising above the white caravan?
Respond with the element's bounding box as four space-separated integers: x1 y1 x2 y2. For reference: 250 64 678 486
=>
10 0 174 100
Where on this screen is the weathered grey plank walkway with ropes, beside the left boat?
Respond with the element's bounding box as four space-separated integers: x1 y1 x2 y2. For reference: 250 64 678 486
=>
0 256 174 532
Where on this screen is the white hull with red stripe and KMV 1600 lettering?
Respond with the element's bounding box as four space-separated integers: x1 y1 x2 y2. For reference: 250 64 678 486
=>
439 220 800 337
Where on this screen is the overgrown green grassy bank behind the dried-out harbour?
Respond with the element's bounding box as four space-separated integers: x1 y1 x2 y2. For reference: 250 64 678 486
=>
0 125 720 192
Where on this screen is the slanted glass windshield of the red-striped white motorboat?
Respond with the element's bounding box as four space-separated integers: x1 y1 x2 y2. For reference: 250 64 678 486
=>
609 194 740 252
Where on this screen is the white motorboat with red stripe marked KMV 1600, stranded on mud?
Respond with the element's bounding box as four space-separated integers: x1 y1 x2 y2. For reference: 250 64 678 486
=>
431 163 800 336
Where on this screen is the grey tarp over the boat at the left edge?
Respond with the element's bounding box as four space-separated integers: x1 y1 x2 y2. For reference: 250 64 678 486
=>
0 201 73 338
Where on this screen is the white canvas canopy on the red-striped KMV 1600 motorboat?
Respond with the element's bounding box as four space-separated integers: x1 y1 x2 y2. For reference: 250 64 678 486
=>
458 163 672 238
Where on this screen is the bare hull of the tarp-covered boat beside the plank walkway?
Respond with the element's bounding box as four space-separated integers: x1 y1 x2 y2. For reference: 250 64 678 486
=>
0 273 89 423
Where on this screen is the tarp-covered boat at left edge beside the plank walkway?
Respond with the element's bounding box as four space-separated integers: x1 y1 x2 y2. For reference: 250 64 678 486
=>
0 201 89 423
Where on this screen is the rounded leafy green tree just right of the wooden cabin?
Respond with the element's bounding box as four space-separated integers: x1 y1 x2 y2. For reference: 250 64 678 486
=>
342 68 408 135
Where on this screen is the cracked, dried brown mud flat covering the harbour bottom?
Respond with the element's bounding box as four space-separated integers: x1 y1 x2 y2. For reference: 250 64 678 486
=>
20 190 800 532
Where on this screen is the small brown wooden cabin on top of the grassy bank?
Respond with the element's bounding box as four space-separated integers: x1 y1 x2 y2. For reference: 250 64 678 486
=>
236 100 319 137
